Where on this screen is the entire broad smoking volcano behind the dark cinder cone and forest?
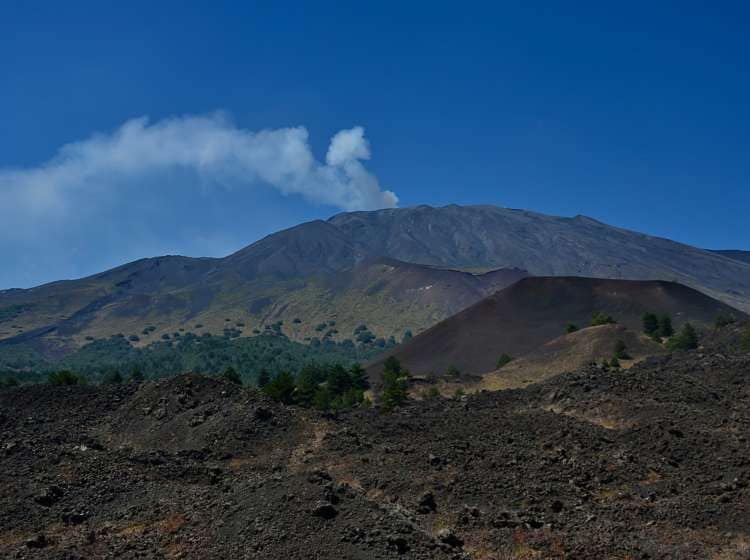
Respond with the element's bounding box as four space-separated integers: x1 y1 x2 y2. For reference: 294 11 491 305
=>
0 205 750 356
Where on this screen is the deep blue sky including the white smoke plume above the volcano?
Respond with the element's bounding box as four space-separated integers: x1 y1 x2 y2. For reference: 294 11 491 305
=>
0 1 750 288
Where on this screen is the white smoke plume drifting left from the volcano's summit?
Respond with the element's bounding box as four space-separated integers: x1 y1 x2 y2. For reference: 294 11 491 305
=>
0 114 398 234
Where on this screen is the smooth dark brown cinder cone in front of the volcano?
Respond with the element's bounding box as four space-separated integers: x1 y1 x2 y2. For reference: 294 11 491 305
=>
368 277 745 378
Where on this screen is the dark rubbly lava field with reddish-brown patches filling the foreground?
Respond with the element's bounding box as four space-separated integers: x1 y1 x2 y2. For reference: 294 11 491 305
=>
0 336 750 560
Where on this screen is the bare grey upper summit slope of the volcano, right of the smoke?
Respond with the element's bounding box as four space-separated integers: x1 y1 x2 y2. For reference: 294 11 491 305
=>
329 205 750 311
